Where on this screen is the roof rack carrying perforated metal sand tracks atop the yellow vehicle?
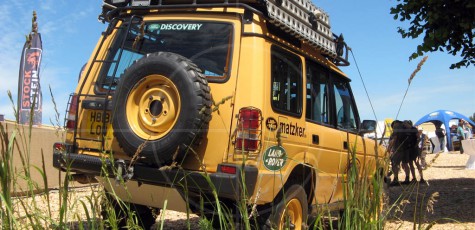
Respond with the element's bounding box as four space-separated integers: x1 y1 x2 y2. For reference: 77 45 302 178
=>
99 0 349 66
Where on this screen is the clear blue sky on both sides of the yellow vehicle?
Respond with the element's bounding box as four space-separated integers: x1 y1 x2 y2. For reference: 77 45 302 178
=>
0 0 475 124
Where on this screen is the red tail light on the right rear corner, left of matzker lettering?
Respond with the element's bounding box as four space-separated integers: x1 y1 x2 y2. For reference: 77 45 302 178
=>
234 107 262 152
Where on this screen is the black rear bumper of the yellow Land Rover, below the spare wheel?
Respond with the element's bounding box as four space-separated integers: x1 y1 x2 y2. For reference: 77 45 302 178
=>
53 145 258 200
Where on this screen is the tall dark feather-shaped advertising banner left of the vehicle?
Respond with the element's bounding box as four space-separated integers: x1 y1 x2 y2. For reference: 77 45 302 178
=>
18 14 43 125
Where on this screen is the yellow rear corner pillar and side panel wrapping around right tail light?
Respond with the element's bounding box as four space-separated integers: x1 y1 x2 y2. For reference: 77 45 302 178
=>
230 33 307 203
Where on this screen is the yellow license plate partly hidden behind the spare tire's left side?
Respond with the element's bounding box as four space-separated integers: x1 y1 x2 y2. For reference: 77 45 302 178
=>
86 110 112 137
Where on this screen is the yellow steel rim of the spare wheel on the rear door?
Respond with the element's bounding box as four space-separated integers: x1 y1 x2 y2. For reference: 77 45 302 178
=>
126 74 181 140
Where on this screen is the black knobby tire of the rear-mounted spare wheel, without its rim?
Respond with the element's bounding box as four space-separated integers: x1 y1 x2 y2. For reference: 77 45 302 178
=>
112 52 212 166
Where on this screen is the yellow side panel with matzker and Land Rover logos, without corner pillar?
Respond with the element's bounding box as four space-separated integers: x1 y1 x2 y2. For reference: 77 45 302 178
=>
257 44 307 202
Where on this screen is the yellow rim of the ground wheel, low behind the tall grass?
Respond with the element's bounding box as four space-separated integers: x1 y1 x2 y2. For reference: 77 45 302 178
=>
279 198 303 230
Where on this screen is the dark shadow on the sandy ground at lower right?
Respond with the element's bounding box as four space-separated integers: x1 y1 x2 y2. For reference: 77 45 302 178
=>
388 178 475 223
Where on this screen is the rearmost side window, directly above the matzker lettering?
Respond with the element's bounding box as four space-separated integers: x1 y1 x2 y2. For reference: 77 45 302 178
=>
271 46 302 116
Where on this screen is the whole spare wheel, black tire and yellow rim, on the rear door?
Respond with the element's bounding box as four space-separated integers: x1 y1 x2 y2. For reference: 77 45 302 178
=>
112 52 212 166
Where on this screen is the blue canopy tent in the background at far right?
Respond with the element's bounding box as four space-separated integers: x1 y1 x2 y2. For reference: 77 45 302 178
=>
414 110 475 149
